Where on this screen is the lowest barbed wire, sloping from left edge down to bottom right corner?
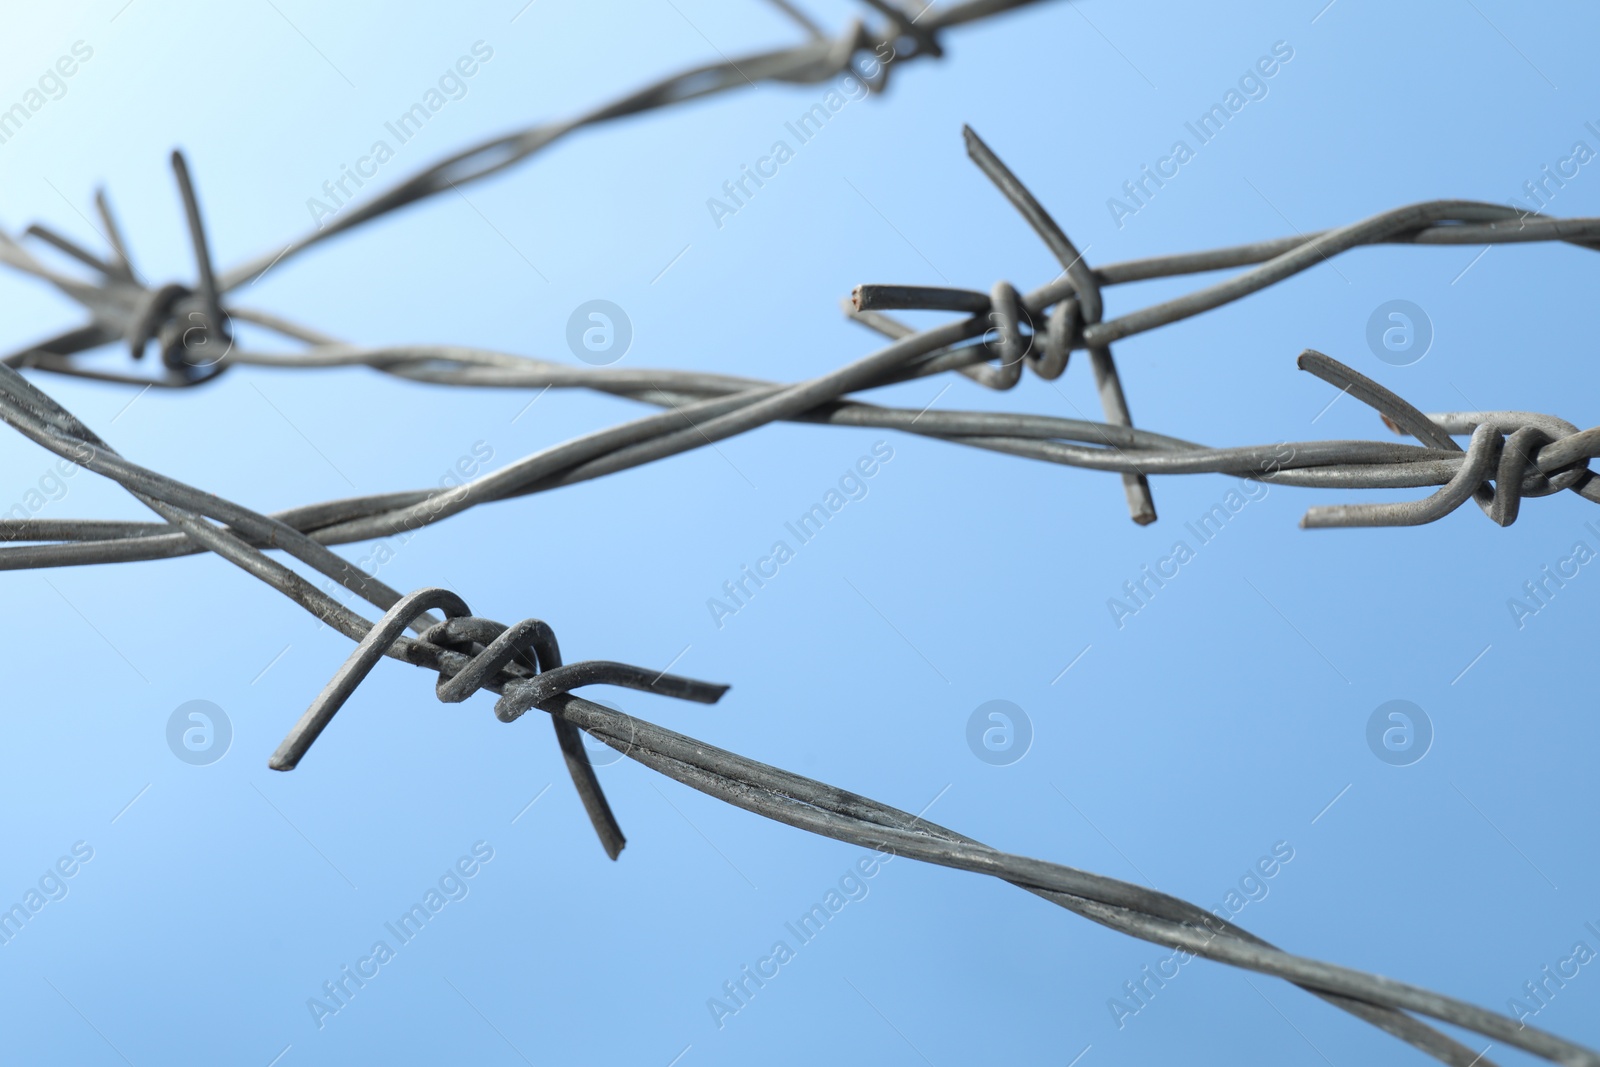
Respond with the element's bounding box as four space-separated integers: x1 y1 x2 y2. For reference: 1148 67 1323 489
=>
0 366 1600 1067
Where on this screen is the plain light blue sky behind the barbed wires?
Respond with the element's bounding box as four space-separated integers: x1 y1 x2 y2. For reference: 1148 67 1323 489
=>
0 0 1600 1067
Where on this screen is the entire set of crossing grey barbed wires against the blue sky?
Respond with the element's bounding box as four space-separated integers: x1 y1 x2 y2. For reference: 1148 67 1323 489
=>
0 0 1600 1067
